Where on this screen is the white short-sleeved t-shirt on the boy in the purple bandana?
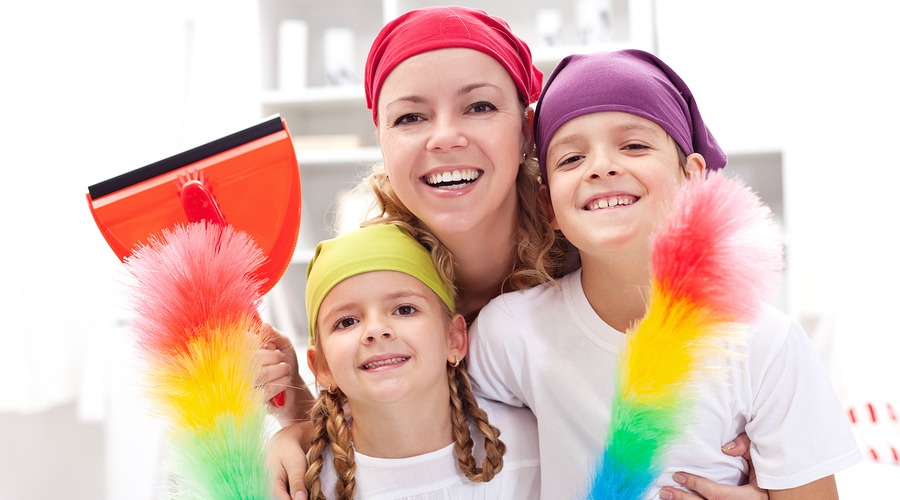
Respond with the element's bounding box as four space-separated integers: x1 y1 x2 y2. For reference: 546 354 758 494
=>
469 270 861 498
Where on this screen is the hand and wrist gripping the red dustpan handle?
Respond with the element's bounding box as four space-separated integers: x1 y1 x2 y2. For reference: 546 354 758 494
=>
254 323 314 426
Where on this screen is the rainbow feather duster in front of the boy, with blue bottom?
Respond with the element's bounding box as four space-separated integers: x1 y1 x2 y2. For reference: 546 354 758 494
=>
588 172 783 500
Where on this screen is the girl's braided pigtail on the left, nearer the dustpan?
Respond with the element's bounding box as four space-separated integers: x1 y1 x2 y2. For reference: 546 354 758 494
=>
304 389 356 500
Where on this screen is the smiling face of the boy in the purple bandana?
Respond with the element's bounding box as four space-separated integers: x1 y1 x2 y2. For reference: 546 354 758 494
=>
547 112 705 255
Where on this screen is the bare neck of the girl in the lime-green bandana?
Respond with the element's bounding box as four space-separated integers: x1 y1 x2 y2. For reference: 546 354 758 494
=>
350 389 453 458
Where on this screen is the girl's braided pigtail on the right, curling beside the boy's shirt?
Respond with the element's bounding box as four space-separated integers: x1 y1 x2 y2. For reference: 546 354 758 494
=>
447 360 506 483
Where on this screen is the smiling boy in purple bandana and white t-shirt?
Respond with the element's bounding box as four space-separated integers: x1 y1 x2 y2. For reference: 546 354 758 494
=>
470 50 860 499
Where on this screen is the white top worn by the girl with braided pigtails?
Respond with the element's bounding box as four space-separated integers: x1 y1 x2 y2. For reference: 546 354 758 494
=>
320 400 541 500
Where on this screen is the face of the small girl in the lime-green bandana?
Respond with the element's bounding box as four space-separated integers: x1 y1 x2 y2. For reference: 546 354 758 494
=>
310 271 466 405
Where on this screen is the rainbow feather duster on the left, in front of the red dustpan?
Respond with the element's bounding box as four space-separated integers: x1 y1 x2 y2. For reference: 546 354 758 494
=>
125 222 269 500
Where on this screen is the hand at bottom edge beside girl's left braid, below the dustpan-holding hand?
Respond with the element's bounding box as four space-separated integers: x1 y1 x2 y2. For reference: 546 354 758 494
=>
266 422 311 500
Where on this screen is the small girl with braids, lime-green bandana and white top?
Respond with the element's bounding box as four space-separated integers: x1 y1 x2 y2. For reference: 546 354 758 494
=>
305 224 540 499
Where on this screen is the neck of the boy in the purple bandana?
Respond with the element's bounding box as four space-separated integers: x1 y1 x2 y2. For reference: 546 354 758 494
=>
581 248 650 333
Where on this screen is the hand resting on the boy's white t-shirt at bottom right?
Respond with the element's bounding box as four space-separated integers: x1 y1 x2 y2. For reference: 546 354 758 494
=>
659 433 769 500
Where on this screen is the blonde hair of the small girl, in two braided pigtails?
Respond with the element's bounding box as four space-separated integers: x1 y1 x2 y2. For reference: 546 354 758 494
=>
304 312 506 500
